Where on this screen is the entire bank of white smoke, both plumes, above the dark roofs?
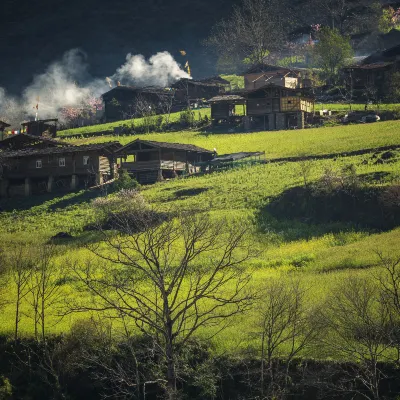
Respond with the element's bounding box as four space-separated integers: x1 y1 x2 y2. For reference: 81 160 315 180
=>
0 49 190 128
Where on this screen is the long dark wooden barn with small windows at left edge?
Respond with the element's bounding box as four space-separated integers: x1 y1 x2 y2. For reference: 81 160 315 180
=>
0 134 121 197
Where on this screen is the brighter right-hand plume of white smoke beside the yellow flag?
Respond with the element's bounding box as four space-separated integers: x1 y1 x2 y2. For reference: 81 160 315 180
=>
112 51 190 87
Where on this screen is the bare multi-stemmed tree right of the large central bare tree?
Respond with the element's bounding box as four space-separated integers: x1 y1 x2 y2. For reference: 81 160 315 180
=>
257 279 319 398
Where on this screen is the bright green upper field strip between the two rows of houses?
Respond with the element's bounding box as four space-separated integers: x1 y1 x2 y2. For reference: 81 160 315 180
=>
71 121 400 158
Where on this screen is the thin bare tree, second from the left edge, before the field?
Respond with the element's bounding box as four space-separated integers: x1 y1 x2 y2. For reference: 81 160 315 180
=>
28 244 65 341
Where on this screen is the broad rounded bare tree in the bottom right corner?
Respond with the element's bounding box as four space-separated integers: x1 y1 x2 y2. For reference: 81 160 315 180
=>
321 276 392 400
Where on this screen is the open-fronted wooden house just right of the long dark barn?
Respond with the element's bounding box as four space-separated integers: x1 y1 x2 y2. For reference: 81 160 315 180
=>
115 139 213 184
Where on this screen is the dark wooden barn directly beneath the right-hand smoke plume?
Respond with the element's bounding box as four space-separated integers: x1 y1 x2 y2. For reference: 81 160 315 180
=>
101 86 173 121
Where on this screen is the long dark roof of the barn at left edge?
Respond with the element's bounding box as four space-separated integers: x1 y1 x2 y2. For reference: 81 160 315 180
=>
1 142 122 158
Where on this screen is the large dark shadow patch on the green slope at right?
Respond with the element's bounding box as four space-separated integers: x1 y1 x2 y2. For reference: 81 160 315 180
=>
256 183 400 241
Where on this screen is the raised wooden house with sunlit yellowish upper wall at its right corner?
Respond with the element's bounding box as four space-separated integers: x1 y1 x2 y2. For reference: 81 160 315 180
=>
245 84 314 130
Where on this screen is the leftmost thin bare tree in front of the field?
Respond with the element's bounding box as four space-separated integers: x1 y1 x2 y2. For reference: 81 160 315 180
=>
6 244 33 340
